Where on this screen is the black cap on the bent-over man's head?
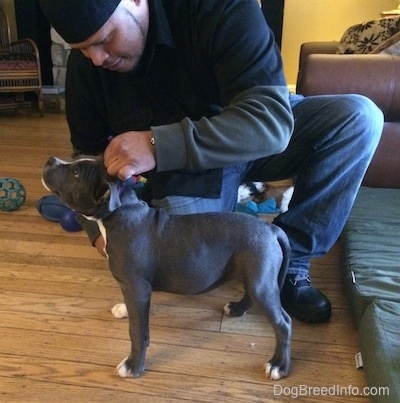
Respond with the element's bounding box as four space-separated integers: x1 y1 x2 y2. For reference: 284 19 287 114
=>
39 0 121 43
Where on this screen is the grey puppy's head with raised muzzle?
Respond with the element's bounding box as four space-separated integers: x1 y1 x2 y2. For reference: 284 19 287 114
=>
42 157 120 218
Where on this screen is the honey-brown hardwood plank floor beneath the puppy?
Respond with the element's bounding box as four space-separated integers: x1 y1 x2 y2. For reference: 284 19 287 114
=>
0 112 369 403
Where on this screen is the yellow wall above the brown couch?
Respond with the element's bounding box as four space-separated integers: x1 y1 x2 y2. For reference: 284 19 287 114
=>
282 0 399 84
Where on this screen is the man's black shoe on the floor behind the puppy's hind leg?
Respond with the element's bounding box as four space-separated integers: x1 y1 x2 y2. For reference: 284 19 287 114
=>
281 274 332 323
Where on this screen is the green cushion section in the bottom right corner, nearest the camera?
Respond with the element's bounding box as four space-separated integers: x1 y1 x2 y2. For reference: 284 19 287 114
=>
359 300 400 403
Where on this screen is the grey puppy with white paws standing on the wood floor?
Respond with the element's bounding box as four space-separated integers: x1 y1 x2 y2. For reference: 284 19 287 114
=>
43 157 291 379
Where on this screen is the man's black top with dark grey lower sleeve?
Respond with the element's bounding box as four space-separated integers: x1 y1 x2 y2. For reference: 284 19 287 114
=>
66 0 293 198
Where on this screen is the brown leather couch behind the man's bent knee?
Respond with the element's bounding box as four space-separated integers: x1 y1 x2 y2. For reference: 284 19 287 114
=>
296 41 400 188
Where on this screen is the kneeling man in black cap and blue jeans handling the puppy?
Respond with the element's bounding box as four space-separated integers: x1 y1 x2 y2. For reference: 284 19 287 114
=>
40 0 383 322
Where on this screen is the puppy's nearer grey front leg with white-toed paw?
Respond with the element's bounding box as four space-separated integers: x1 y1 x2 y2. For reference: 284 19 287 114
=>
116 279 151 378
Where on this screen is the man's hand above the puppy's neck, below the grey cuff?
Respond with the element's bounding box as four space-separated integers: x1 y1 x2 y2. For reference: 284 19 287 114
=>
104 130 156 180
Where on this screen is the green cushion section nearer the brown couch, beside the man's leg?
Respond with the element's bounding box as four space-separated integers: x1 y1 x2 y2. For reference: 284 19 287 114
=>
341 187 400 324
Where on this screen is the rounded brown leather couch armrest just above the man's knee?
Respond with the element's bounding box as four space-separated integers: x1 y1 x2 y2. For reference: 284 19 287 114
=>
296 54 400 122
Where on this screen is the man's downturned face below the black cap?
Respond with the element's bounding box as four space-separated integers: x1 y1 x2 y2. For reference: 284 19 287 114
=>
71 0 149 73
